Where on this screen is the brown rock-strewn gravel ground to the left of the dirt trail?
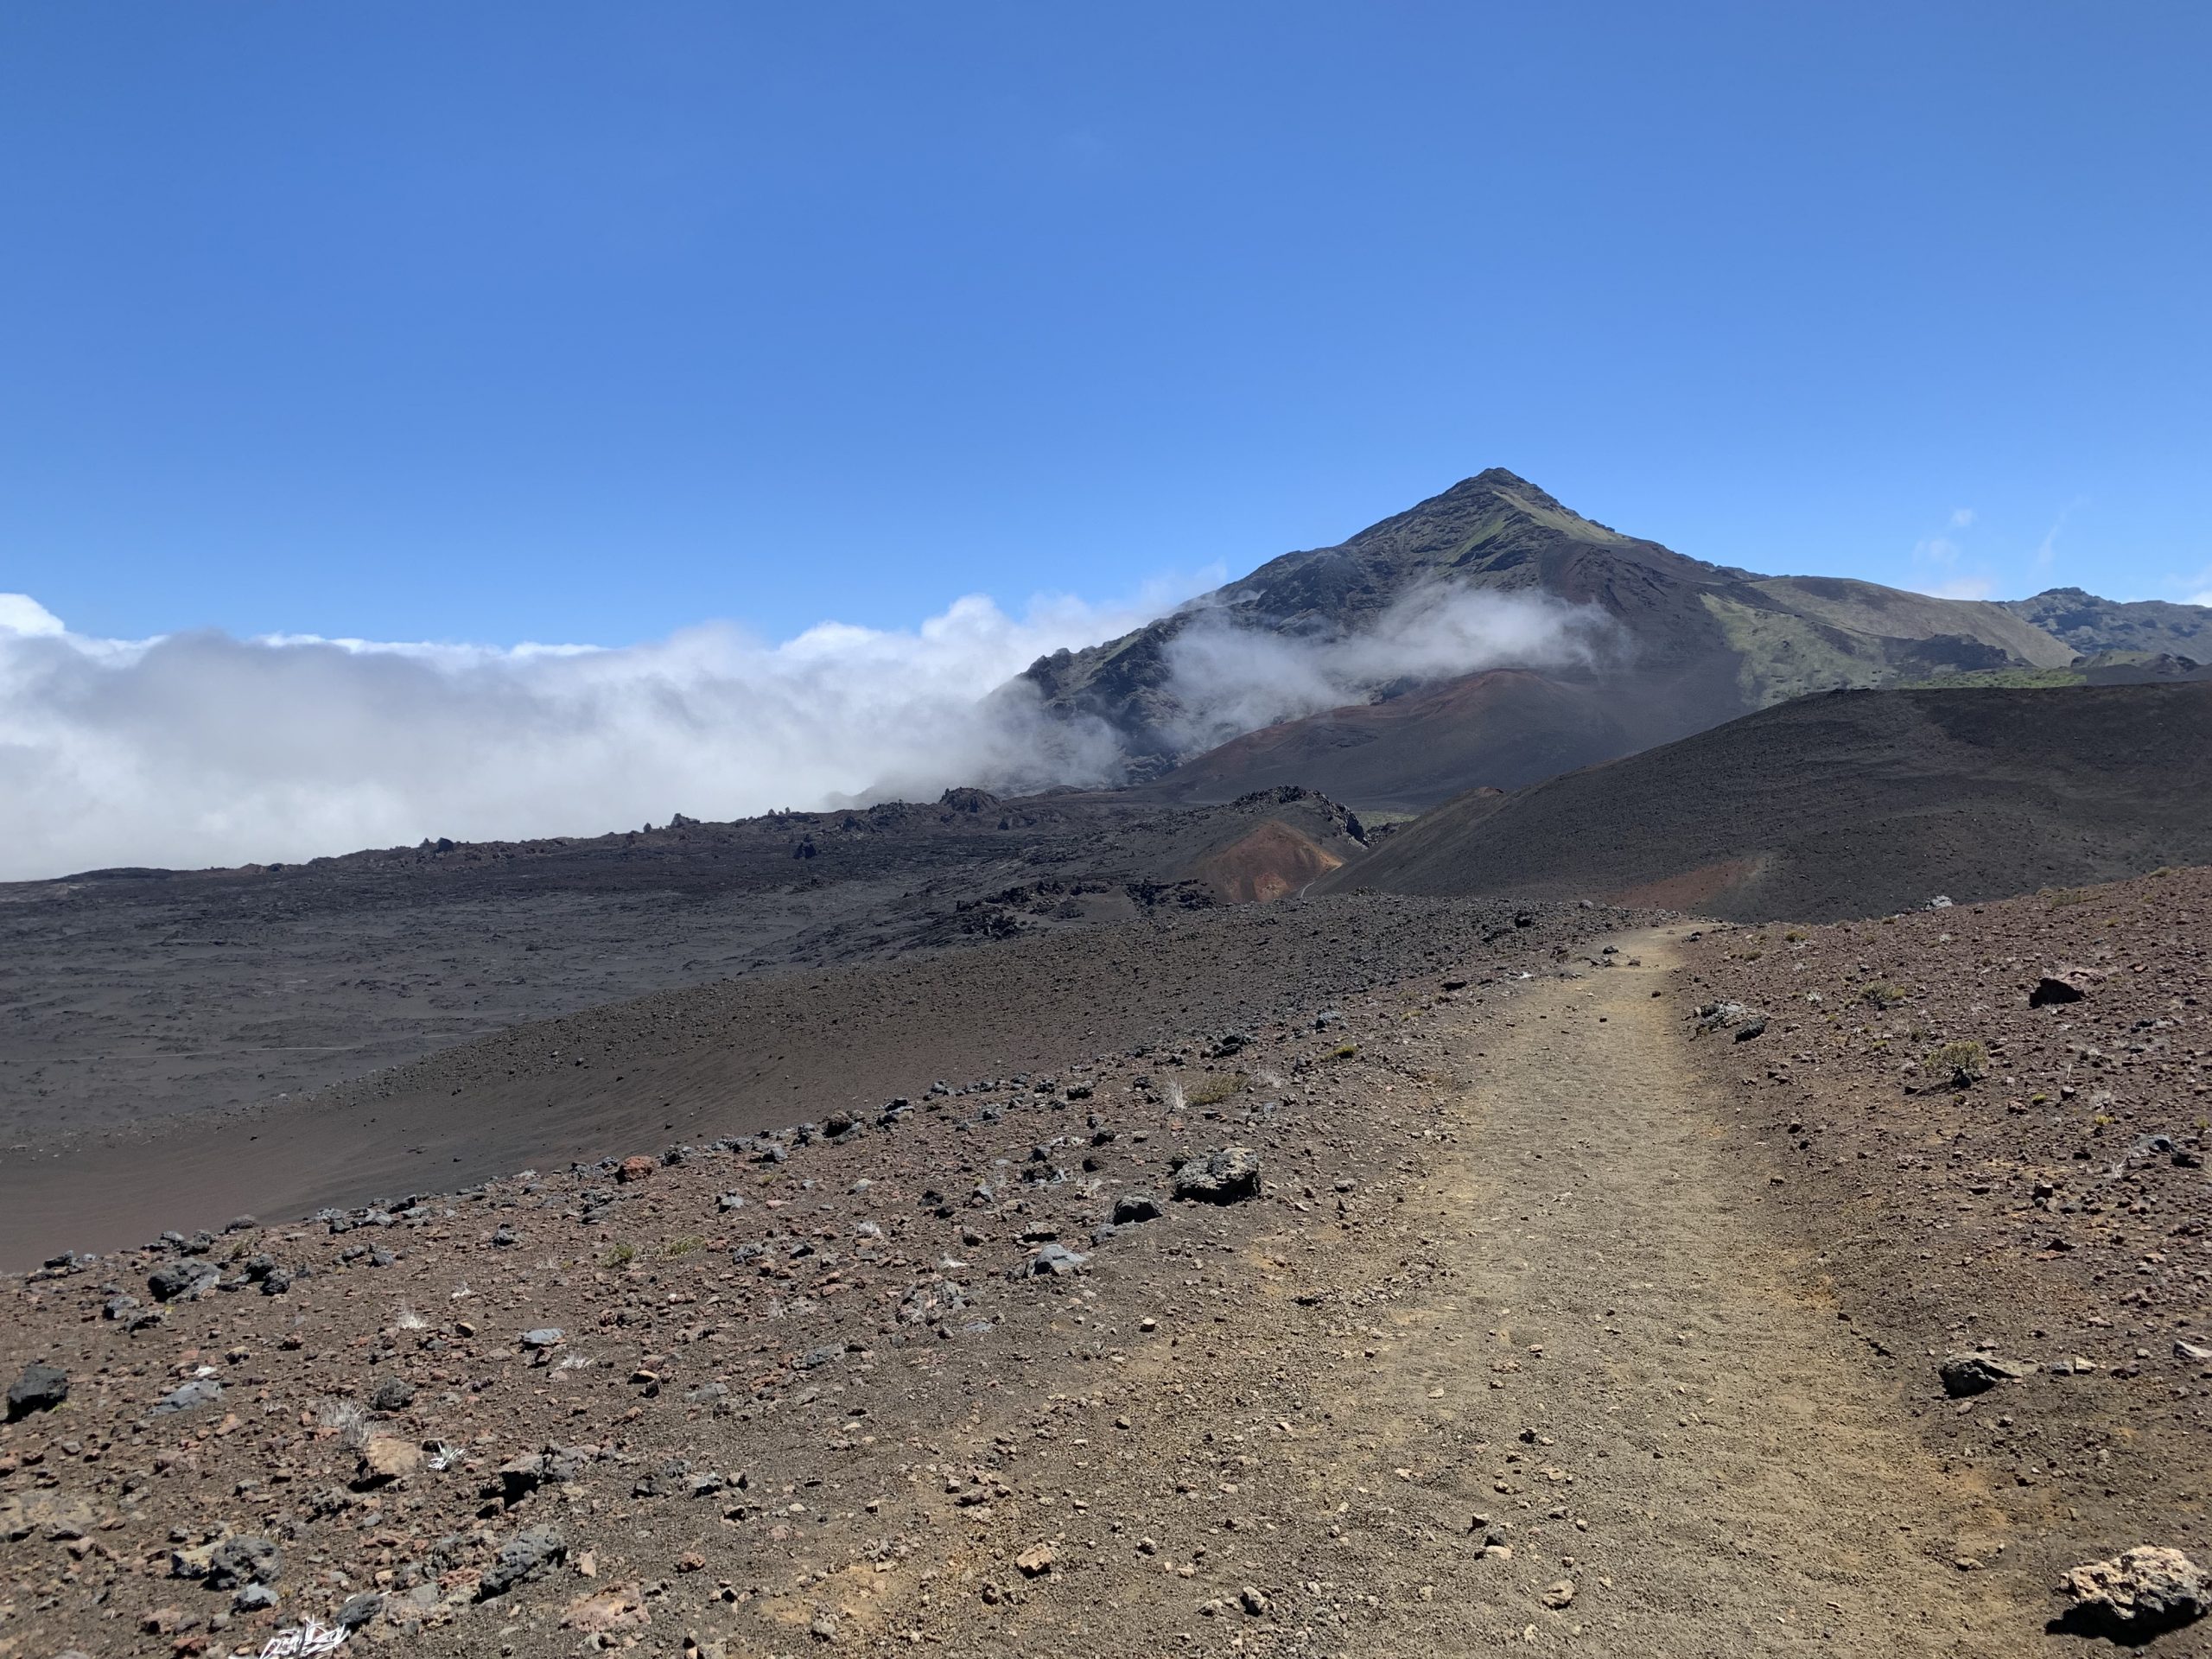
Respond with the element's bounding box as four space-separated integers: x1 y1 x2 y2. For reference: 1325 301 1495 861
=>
0 907 1630 1655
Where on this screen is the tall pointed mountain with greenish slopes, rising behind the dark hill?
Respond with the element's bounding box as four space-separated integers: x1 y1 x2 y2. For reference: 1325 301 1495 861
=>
1024 469 2177 810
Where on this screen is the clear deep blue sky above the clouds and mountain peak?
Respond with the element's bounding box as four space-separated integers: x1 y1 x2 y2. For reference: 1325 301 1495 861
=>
0 0 2212 644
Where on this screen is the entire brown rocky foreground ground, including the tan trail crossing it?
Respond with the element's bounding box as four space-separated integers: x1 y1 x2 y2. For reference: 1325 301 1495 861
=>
0 872 2212 1659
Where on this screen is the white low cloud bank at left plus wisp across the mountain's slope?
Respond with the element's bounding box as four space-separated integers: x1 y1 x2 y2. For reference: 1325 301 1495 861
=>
0 588 1586 880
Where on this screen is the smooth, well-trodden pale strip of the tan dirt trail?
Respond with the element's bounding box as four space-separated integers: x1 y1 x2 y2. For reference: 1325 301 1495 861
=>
1292 933 2044 1655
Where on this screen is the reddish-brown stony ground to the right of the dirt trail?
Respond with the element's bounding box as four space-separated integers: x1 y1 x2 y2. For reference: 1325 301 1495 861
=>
1690 869 2212 1652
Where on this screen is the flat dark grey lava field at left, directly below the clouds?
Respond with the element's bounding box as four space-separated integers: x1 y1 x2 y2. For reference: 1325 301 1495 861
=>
0 790 1363 1161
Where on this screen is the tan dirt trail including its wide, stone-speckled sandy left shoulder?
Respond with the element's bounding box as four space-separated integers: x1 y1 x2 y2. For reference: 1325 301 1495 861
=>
892 933 2066 1659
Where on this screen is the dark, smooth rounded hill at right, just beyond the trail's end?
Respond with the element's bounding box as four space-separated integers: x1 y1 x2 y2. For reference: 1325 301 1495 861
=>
1314 683 2212 923
